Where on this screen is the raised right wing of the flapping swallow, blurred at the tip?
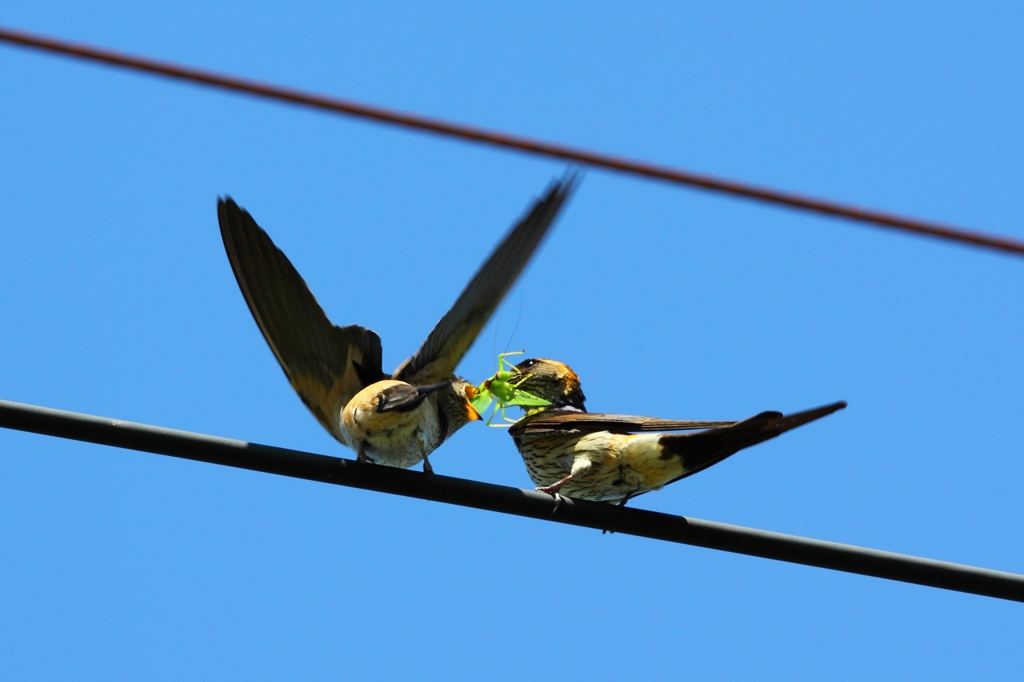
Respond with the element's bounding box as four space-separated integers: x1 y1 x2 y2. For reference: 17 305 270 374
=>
394 174 577 384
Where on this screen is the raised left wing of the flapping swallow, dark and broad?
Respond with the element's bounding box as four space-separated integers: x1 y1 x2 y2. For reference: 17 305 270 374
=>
217 197 384 437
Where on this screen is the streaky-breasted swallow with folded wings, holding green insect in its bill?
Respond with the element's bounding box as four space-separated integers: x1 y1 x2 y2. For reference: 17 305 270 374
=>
497 358 846 501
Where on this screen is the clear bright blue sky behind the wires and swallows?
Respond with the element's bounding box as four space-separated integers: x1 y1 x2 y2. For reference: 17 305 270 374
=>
0 0 1024 680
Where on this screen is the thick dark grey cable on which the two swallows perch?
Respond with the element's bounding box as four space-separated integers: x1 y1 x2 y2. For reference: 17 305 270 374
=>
0 400 1024 601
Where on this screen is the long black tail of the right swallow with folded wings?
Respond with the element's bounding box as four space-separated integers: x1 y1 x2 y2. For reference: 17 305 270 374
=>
658 400 846 483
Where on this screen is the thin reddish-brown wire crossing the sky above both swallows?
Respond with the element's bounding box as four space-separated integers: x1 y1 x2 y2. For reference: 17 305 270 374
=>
0 27 1024 255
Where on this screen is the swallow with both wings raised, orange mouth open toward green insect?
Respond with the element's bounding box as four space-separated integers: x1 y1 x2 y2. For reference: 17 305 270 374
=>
217 175 575 472
